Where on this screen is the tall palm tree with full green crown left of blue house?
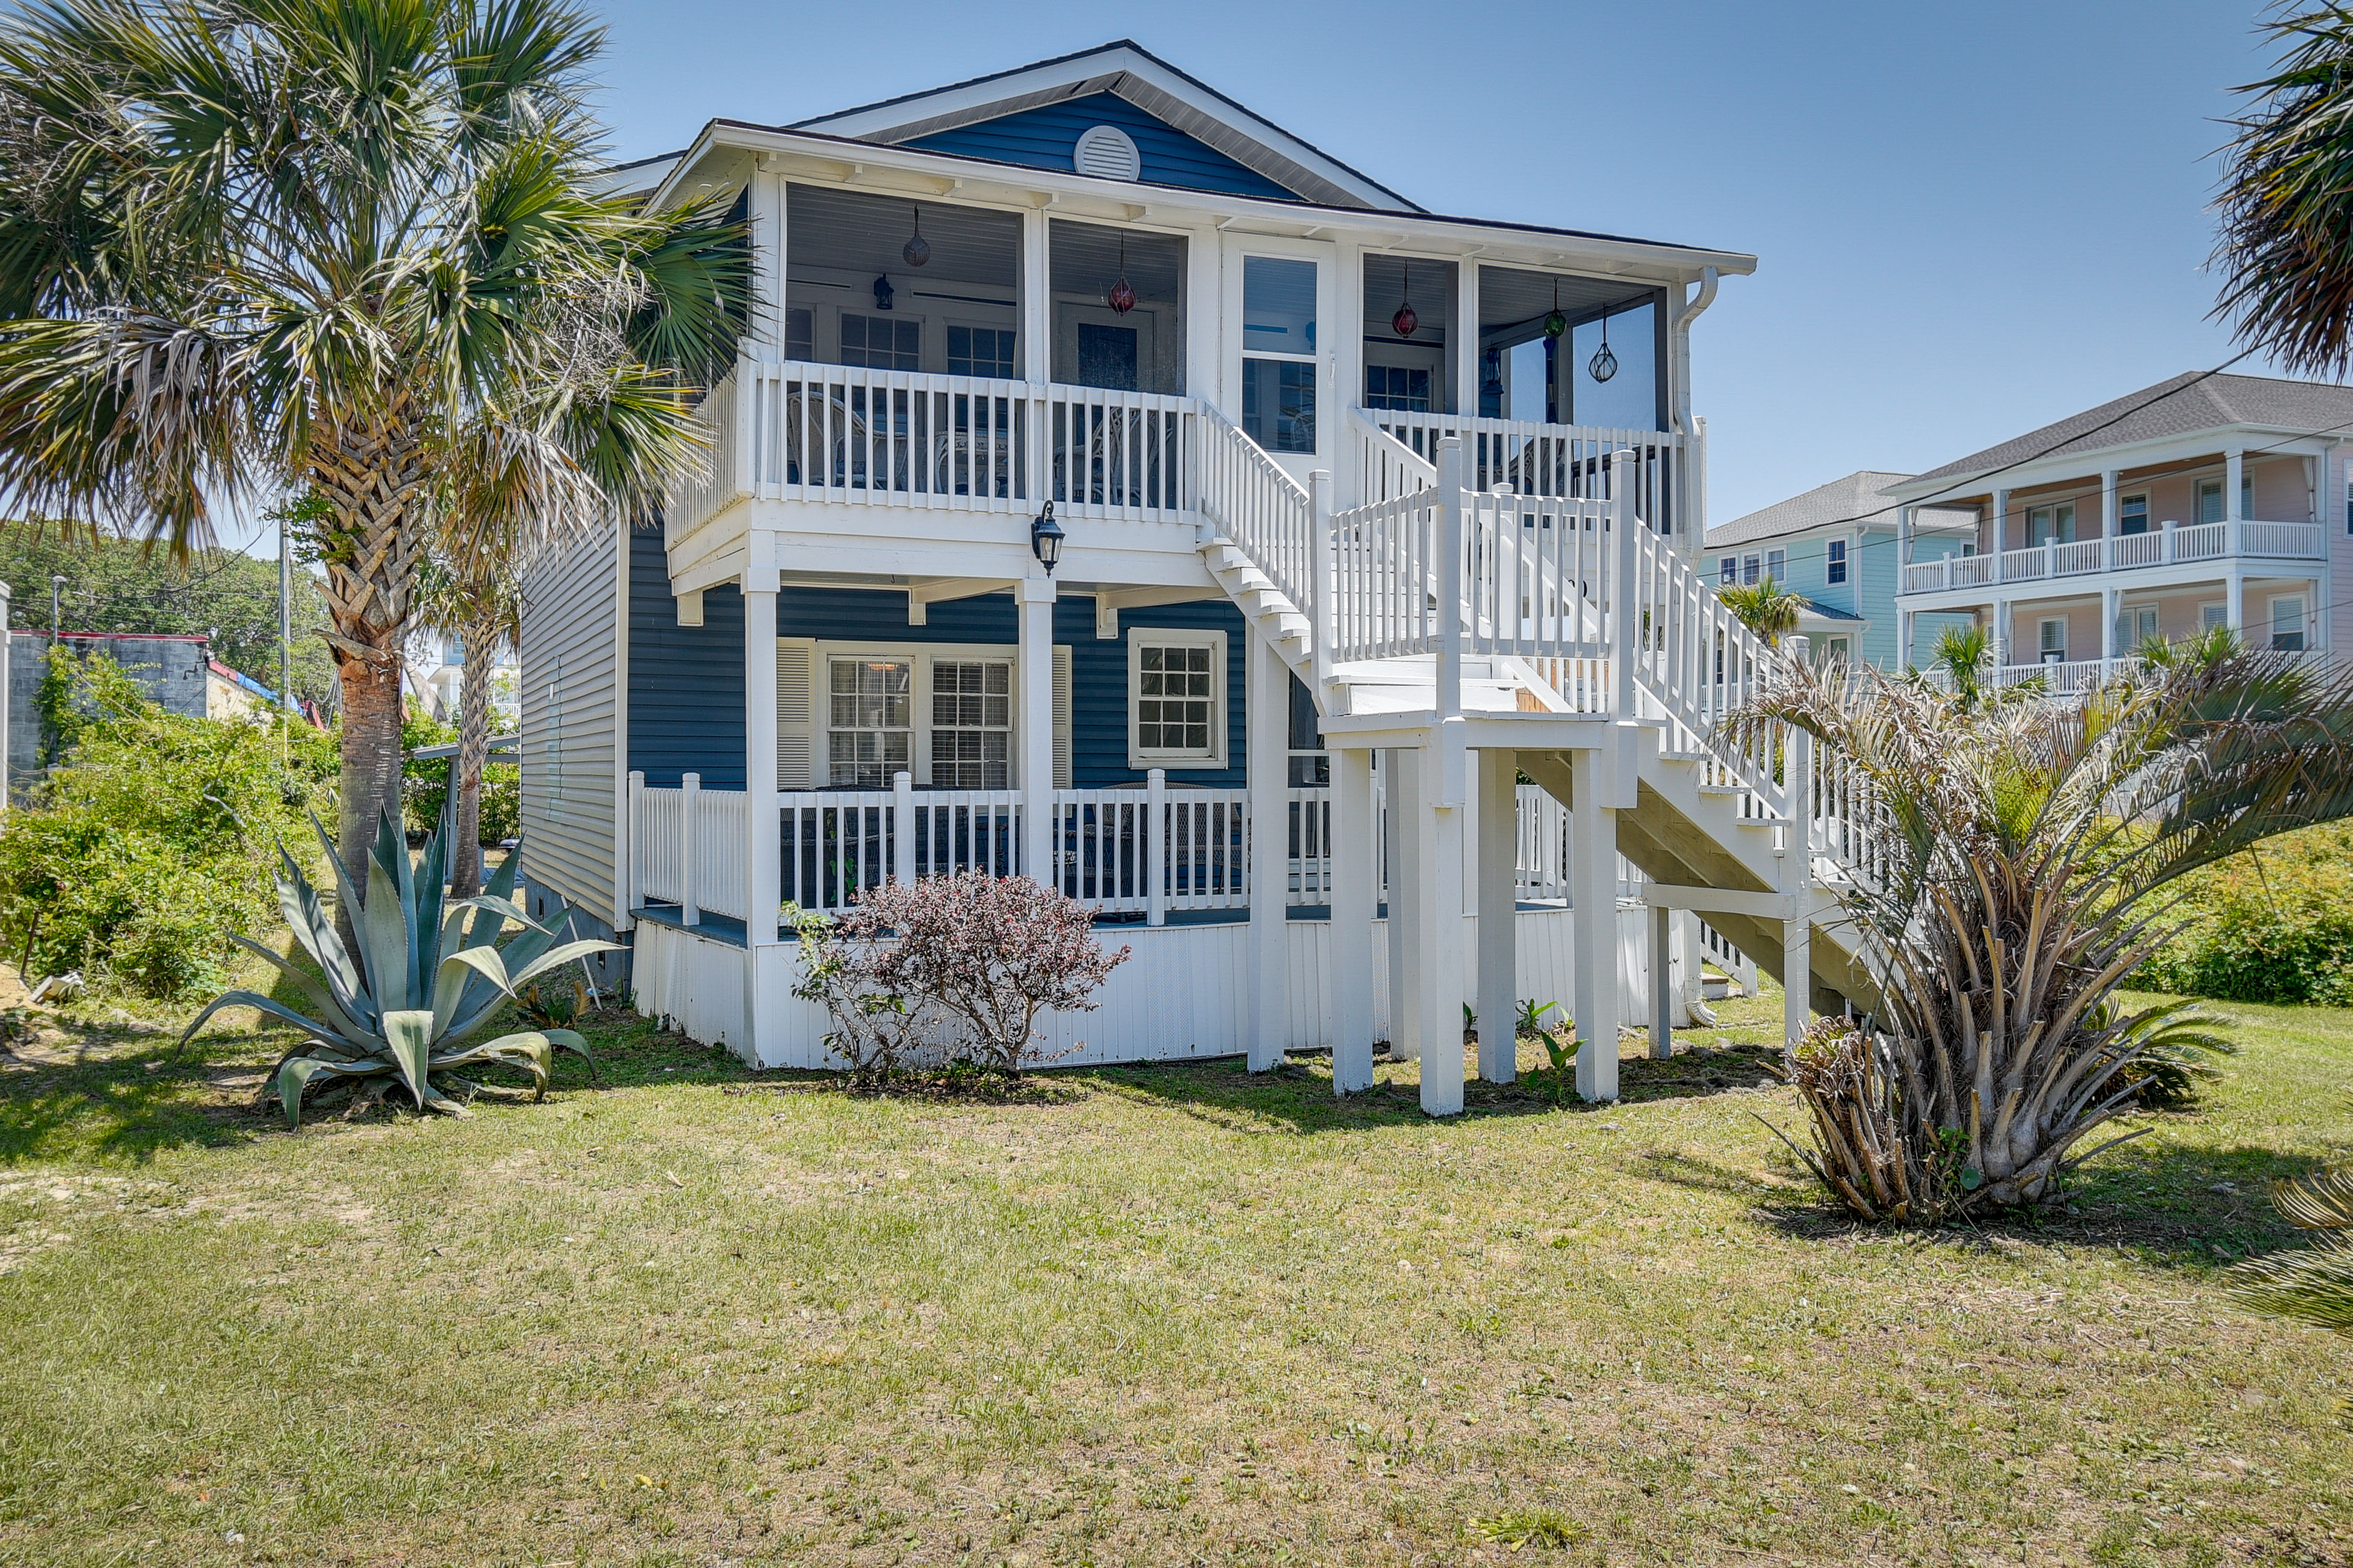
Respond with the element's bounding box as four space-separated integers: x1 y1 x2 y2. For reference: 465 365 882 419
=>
0 0 748 863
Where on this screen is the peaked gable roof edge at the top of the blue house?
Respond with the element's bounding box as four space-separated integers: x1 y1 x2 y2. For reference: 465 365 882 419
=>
786 37 1421 212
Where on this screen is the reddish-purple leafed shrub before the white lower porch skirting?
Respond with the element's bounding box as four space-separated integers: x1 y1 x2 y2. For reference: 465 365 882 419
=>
800 872 1127 1077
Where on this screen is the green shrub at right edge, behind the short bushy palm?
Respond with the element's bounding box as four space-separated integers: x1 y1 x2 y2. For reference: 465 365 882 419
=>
2139 823 2353 1006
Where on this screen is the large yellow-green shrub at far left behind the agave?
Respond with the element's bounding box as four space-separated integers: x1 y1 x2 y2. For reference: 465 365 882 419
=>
0 651 336 999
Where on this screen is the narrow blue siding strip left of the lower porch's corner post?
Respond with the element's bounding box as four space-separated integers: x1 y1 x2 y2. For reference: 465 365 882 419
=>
629 529 743 790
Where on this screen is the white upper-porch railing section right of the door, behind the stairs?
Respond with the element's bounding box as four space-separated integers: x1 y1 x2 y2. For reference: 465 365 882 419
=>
1365 409 1683 531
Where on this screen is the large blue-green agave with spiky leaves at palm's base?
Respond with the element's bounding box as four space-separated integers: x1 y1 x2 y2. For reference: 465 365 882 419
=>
181 814 617 1128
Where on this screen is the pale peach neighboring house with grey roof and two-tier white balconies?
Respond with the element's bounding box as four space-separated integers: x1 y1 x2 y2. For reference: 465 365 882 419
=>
1887 374 2353 689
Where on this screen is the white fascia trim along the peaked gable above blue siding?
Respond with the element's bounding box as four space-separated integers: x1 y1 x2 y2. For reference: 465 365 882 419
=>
793 47 1412 207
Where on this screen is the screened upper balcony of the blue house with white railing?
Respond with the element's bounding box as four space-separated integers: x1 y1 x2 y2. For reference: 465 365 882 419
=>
666 183 1703 588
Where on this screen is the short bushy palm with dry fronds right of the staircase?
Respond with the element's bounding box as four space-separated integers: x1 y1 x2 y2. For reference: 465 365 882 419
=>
1748 646 2353 1220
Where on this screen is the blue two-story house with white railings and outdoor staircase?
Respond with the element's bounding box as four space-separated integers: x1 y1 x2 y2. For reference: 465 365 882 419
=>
522 42 1866 1112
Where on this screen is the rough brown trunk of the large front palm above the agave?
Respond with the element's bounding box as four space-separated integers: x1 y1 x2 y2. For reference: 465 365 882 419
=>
308 392 426 886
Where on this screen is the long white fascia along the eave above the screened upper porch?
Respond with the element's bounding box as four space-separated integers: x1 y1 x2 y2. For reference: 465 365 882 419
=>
652 120 1758 285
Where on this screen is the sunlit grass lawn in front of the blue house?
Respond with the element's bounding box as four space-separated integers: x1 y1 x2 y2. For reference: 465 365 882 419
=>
0 973 2353 1568
